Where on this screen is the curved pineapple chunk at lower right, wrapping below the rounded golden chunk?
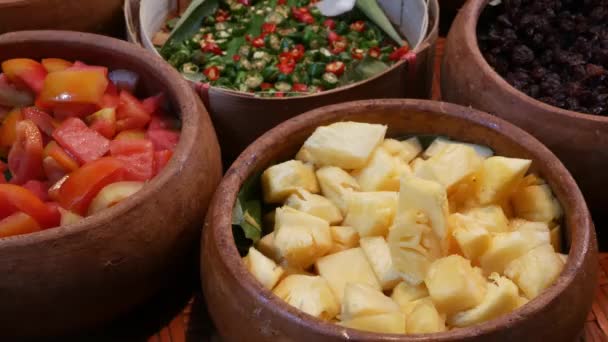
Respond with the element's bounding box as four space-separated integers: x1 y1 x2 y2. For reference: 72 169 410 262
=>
448 273 520 327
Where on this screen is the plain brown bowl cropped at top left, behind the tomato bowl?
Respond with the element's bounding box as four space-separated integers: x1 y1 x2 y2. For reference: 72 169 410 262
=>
0 0 124 35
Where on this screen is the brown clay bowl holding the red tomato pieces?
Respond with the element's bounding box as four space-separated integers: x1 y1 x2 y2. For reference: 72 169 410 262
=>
0 31 221 340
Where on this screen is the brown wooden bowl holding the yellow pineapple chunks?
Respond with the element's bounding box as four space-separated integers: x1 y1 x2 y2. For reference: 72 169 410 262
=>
201 100 597 342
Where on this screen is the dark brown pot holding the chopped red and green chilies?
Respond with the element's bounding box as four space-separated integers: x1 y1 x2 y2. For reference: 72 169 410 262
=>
127 0 439 165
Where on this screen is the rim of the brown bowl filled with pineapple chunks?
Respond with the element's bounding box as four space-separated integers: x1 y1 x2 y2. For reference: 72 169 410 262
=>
202 99 595 341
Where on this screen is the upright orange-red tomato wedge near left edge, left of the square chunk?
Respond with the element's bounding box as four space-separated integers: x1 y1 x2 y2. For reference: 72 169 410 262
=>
8 120 44 184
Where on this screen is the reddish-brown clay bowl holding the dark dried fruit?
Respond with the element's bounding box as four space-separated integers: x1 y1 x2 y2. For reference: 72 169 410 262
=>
441 0 608 240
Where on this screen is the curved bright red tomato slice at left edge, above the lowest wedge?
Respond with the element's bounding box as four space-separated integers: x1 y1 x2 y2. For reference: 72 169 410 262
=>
0 184 61 228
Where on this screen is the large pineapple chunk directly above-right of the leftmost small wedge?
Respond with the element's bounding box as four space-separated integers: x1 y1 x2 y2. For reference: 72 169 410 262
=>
274 207 332 268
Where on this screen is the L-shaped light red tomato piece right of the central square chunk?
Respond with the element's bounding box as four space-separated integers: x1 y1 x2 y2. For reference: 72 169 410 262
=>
110 139 154 182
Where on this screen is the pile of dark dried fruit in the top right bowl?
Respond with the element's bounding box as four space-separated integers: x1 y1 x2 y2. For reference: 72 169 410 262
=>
477 0 608 115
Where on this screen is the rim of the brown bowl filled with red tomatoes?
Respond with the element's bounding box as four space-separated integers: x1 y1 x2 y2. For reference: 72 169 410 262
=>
0 30 204 249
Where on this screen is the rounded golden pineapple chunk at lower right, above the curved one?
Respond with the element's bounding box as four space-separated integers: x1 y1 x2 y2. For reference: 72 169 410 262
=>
424 254 486 315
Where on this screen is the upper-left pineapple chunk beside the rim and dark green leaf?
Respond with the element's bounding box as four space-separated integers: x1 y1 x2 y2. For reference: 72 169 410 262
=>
262 160 319 203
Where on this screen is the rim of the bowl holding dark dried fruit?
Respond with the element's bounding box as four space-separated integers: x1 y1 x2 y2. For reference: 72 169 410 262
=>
460 0 608 123
